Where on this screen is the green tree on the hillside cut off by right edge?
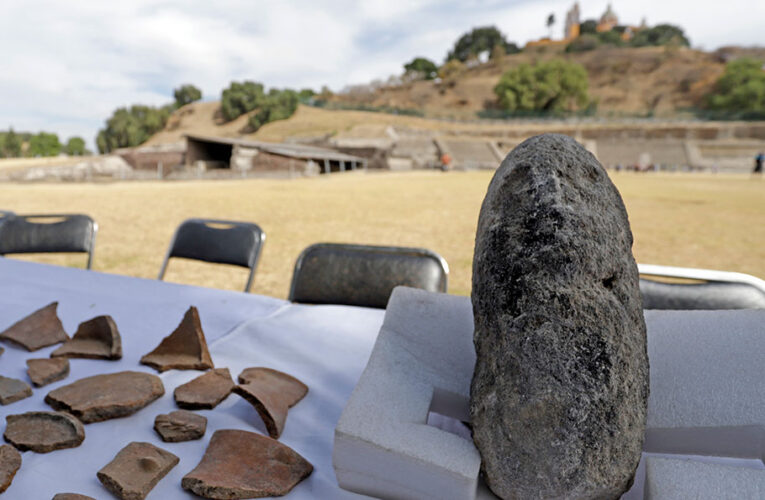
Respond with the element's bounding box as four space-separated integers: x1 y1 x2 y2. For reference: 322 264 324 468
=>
707 57 765 113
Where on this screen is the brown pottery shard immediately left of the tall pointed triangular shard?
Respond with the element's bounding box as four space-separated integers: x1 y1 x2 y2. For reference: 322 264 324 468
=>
50 316 122 359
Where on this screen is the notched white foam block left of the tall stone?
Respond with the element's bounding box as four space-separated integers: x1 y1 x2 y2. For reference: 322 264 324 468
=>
332 287 481 499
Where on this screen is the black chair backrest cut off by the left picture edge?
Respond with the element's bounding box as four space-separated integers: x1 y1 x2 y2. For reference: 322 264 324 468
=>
0 214 98 269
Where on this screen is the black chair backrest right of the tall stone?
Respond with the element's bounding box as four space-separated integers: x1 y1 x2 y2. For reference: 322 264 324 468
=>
640 278 765 309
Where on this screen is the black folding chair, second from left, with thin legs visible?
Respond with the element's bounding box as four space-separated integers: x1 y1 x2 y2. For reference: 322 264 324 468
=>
158 219 266 292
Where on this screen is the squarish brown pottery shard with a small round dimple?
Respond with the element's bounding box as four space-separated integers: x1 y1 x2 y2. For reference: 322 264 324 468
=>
96 441 180 500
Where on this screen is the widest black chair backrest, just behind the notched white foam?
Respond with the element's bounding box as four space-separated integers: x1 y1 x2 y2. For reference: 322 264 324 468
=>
289 243 449 309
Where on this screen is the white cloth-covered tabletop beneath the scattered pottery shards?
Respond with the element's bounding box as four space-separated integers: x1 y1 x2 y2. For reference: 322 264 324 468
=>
0 258 384 500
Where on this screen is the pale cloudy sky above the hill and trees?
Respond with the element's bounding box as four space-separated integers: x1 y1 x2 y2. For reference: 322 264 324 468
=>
0 0 765 148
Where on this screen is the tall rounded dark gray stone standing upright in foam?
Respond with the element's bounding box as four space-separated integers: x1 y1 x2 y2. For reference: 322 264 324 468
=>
470 134 648 499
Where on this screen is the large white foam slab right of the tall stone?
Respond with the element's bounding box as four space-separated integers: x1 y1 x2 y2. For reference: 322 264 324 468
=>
644 310 765 458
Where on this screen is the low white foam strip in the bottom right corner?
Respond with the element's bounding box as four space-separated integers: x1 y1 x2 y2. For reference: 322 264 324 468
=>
644 457 765 500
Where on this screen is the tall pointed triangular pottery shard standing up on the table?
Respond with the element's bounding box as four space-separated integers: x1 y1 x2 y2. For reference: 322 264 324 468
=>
141 306 214 372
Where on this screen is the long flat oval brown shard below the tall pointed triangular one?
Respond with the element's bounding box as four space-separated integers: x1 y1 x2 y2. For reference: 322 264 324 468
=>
45 371 165 424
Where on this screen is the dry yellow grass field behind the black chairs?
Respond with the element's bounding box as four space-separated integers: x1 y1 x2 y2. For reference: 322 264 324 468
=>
0 172 765 297
